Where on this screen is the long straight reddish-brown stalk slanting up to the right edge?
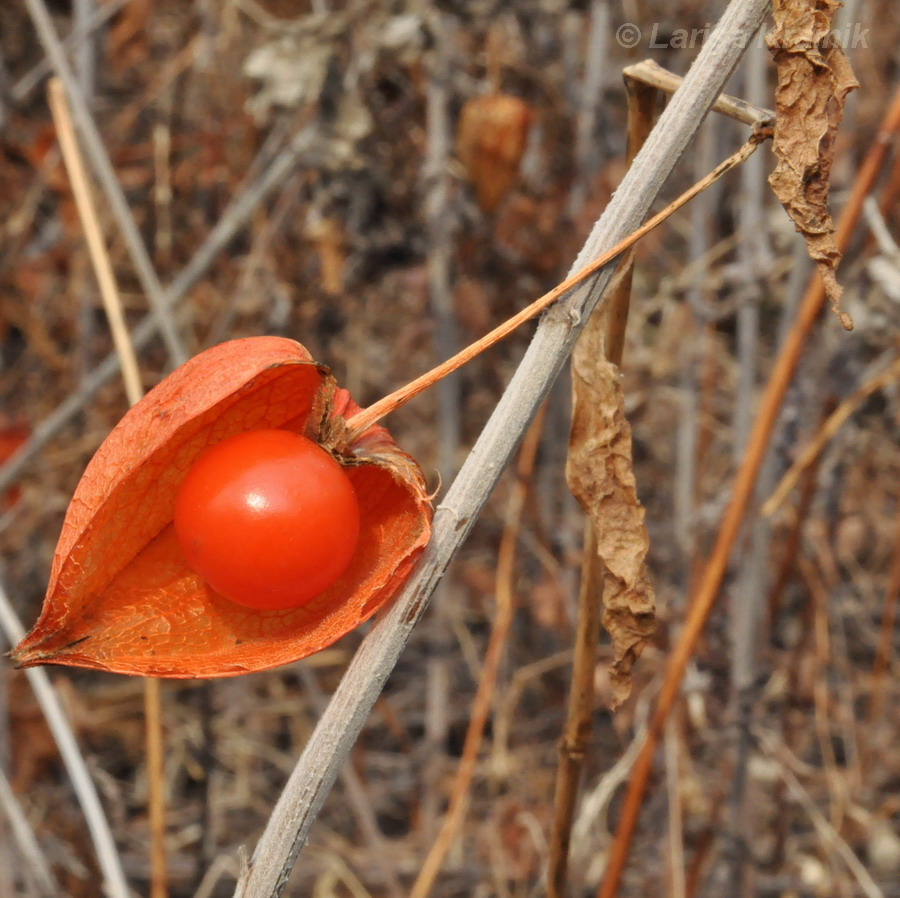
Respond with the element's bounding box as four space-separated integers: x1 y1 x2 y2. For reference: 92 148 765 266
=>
598 80 900 898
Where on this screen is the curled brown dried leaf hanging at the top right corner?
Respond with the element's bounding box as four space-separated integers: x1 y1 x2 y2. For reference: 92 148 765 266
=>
766 0 859 330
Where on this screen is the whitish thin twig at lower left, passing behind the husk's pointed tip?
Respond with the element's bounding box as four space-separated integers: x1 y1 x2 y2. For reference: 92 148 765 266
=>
0 585 131 898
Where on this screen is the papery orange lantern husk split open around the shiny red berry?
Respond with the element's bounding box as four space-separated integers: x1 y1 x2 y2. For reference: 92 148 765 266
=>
11 337 432 677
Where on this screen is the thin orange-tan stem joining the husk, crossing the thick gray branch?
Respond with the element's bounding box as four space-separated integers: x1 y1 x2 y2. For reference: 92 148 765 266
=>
347 129 771 433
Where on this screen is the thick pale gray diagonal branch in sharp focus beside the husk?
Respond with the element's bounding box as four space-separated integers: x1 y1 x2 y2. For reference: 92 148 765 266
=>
235 0 769 898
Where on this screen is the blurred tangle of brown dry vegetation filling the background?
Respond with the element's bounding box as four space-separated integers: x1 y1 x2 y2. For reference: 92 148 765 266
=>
0 0 900 898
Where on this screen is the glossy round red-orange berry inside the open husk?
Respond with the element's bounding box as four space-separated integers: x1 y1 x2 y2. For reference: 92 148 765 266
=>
175 430 359 609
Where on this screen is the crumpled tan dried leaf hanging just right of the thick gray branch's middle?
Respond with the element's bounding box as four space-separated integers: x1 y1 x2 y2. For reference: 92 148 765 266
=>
566 314 656 707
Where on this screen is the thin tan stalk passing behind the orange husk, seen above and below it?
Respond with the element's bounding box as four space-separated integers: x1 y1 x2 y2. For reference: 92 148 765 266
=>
47 78 168 898
